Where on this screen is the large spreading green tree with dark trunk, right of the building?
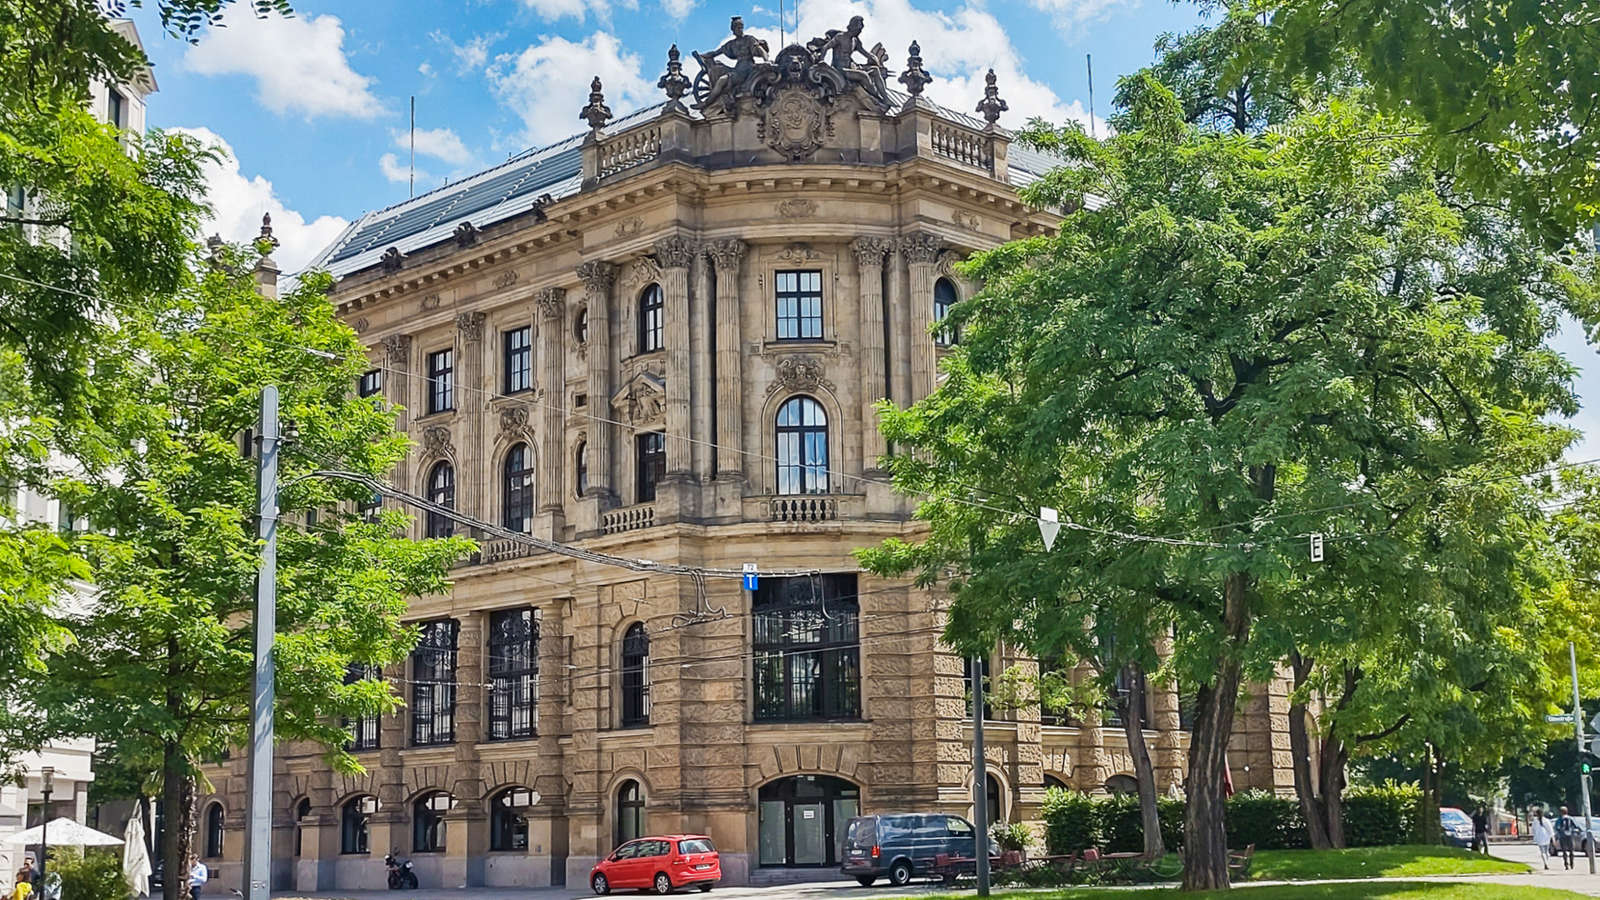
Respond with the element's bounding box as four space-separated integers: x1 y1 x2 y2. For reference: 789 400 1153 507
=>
864 77 1595 889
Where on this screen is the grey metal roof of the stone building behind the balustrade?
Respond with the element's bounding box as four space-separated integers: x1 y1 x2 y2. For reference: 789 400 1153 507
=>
306 91 1059 277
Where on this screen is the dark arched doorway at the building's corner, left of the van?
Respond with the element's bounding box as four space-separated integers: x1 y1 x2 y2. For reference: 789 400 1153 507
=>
758 775 861 868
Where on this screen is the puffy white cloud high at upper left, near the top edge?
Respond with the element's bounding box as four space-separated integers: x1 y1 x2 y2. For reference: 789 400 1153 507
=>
184 3 384 119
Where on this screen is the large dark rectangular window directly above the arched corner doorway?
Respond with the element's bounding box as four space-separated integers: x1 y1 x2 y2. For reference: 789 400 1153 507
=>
752 572 861 721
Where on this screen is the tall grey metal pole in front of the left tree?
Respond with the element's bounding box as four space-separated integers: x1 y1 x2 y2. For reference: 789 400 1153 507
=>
241 384 282 900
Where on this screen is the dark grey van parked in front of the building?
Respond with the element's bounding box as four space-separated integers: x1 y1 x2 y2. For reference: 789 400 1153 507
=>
840 812 976 887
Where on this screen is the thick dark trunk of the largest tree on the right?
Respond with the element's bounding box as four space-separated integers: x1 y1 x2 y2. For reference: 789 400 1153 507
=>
1182 572 1250 890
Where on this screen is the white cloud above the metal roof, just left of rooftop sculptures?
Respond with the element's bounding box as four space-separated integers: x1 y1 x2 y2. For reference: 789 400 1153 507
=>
488 32 658 146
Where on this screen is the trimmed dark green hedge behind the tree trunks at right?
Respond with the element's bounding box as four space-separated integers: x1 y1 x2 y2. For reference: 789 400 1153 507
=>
1042 781 1421 855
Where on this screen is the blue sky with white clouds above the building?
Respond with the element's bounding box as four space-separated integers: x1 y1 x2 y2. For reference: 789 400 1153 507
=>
121 0 1600 460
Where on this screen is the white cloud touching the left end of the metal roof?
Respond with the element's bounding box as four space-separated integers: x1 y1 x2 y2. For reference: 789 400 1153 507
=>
173 128 350 272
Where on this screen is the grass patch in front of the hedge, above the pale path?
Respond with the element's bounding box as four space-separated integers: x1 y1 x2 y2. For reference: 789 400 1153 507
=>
1250 844 1528 881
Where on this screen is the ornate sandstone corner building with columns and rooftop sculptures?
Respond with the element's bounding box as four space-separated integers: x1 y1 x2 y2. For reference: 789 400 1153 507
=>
200 19 1290 890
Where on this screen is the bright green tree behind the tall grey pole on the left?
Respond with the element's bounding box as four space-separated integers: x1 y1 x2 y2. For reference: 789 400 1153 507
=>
17 248 470 900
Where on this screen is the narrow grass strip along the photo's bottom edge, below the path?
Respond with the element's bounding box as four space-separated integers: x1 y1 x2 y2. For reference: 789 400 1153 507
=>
928 881 1584 900
